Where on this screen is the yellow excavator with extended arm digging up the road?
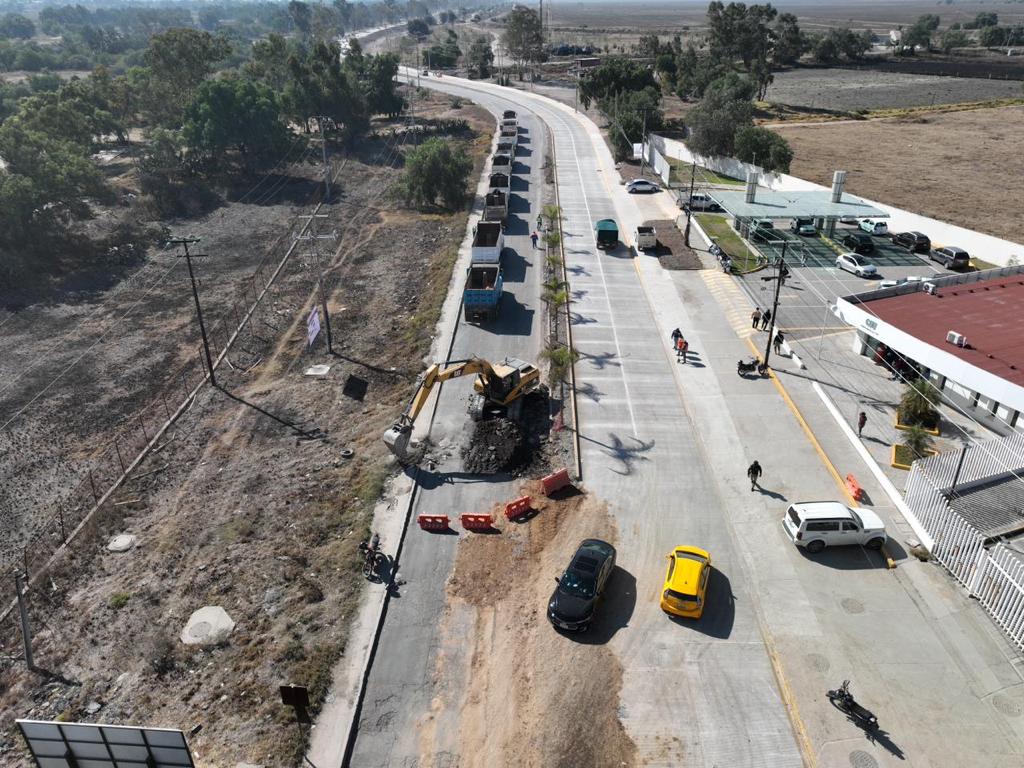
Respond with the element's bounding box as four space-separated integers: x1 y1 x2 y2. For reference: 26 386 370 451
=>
384 357 541 461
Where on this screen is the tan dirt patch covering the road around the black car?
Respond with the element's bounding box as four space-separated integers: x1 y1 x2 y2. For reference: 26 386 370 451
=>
444 483 636 768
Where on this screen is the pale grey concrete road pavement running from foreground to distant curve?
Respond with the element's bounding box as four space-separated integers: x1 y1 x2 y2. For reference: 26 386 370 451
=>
342 72 1024 767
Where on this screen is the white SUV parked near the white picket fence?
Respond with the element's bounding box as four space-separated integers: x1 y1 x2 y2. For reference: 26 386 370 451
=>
782 502 886 552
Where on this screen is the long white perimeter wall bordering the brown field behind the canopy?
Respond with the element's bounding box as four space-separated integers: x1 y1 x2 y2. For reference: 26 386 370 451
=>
650 134 1024 266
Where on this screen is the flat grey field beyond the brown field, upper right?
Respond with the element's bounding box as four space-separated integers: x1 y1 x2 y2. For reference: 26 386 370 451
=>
766 69 1024 111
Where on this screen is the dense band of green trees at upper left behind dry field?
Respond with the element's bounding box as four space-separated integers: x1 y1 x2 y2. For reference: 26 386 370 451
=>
0 29 403 286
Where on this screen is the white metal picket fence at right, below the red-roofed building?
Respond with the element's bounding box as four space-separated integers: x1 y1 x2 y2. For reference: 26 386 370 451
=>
904 433 1024 650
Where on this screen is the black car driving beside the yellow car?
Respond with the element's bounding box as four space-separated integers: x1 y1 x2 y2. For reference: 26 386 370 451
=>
548 539 615 632
